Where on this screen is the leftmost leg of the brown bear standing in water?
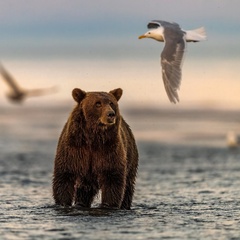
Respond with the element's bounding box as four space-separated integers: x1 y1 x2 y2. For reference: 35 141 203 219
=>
53 173 75 206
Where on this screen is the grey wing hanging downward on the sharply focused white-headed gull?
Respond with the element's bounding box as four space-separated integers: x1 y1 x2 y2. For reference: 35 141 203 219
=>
161 28 186 103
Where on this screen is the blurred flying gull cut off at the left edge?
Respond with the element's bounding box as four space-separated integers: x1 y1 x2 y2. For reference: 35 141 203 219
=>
0 64 56 103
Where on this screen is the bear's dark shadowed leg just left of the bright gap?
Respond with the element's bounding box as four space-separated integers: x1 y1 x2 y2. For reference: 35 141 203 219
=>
75 179 99 208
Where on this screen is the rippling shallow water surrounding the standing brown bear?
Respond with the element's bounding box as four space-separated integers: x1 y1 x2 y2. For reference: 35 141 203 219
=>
0 108 240 239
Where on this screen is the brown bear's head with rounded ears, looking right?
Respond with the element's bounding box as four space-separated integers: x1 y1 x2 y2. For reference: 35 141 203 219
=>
72 88 123 128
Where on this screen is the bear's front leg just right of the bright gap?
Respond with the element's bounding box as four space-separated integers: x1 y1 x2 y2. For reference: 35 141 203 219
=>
101 171 126 209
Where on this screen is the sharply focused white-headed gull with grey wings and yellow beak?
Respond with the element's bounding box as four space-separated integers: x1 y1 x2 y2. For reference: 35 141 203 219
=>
138 20 206 103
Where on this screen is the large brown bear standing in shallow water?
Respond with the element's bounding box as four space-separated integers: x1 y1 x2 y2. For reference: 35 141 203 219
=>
53 88 138 209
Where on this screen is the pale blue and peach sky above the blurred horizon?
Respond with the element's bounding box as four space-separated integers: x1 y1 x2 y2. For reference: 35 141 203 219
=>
0 0 240 108
